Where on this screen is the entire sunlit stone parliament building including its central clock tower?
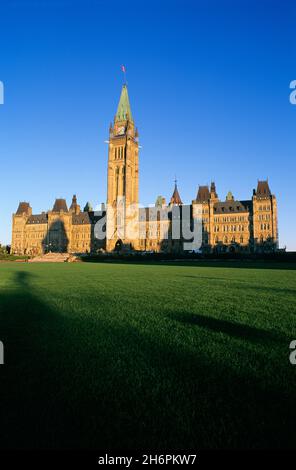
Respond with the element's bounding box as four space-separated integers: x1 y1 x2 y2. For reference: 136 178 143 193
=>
11 85 278 255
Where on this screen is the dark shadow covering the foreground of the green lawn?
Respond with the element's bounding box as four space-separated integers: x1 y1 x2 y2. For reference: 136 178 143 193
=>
0 271 296 450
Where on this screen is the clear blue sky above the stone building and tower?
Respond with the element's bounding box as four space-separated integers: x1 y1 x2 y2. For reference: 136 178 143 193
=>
0 0 296 250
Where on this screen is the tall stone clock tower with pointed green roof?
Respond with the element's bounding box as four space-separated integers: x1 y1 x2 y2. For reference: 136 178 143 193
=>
106 84 139 251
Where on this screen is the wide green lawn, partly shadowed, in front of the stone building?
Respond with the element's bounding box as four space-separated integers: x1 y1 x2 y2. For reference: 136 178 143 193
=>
0 262 296 450
